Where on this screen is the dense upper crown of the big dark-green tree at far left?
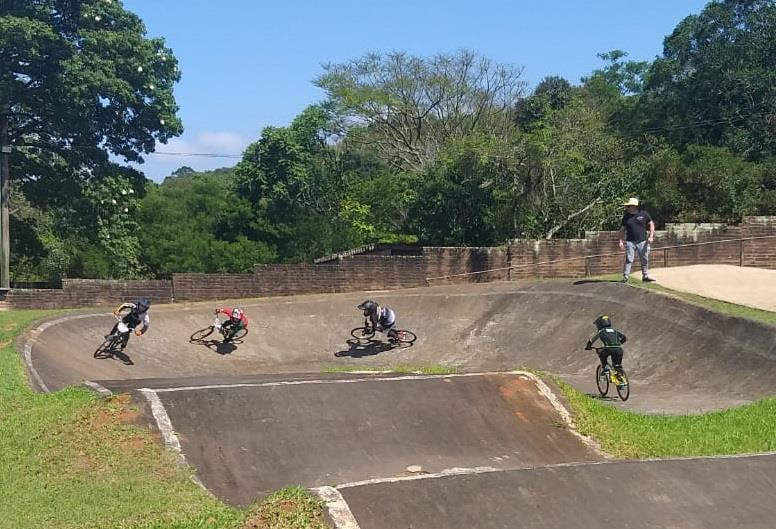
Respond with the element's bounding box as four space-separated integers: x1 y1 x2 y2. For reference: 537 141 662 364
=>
0 0 182 175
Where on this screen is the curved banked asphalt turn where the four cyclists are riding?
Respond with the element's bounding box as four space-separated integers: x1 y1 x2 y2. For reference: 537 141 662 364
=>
25 281 776 413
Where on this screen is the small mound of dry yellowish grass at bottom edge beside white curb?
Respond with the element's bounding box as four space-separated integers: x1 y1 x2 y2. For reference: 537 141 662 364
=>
243 487 329 529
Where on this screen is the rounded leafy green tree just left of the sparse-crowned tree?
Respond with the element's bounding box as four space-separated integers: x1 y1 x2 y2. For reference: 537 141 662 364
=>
235 105 392 261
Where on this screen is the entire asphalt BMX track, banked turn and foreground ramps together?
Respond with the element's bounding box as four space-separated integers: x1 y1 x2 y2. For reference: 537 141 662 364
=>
23 281 776 529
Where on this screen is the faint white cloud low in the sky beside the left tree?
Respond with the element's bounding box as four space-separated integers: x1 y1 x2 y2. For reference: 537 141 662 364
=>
135 130 252 182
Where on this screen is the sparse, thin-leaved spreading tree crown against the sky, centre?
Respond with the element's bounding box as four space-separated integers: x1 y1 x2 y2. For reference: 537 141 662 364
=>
316 51 525 170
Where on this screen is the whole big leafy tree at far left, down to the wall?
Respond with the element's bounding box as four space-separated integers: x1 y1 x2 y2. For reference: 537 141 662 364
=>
0 0 182 277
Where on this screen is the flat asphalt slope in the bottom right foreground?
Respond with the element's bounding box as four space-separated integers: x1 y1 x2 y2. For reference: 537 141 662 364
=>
338 455 776 529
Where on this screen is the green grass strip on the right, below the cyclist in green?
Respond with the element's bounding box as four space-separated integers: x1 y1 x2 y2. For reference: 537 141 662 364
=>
553 377 776 459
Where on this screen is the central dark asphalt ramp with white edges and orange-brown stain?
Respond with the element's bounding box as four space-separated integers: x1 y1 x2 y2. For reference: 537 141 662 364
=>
124 374 601 504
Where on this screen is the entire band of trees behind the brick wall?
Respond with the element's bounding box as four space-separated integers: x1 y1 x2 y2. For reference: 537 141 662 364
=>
6 0 776 281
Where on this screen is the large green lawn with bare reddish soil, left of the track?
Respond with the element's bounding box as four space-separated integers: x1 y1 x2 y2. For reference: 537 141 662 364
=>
0 311 320 529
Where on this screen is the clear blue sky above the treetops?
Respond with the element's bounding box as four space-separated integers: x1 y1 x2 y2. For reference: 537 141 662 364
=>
124 0 707 181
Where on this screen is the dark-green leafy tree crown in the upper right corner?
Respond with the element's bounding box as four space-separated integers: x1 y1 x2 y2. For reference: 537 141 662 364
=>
643 0 776 159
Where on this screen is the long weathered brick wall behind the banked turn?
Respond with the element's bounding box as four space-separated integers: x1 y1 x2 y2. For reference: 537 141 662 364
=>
6 217 776 308
